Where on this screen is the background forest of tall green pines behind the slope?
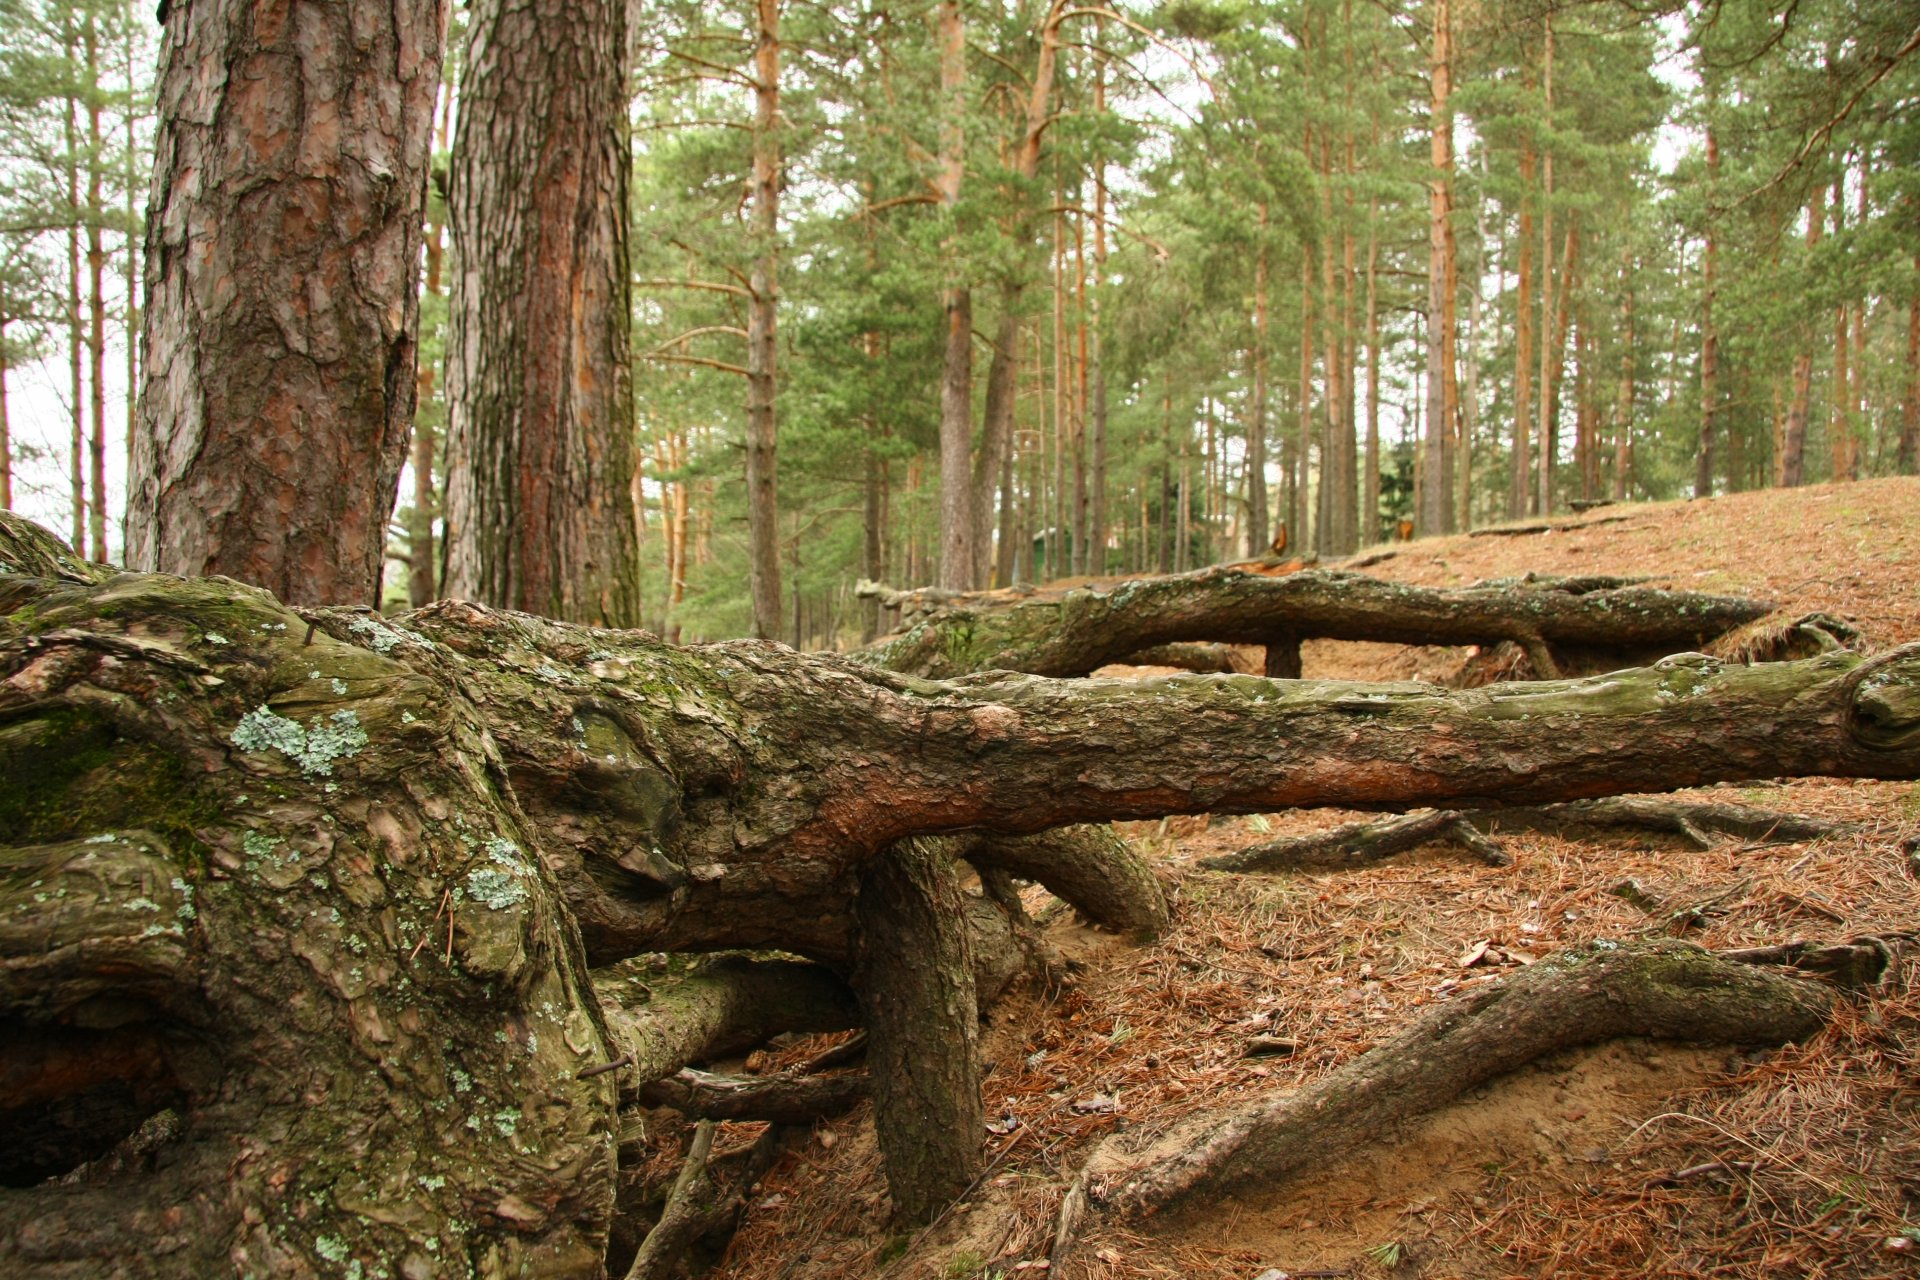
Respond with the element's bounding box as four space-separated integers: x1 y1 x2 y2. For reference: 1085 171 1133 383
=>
0 0 1920 647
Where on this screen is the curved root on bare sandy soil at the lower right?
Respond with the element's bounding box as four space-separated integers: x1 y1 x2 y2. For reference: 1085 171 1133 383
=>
1056 940 1885 1243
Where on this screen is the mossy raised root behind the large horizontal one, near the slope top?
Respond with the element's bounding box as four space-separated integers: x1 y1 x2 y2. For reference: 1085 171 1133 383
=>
860 568 1768 679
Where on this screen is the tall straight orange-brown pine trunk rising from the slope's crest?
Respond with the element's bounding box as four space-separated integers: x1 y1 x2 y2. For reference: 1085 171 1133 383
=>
1419 0 1453 533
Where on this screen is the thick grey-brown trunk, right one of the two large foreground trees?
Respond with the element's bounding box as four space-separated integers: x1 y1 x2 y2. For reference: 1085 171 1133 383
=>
445 0 639 626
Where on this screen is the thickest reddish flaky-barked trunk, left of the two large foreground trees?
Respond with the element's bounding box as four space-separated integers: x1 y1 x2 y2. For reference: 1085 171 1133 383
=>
127 0 447 604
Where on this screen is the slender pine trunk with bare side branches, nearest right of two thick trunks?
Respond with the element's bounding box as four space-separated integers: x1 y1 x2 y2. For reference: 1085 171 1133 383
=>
744 0 783 639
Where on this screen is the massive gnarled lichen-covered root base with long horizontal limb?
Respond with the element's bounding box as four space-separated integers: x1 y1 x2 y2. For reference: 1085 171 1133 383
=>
0 526 1920 1276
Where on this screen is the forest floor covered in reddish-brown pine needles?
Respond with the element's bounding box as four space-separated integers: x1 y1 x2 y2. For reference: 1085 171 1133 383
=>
657 480 1920 1280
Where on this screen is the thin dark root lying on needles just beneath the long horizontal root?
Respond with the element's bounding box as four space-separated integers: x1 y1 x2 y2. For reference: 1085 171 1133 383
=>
1200 796 1847 871
